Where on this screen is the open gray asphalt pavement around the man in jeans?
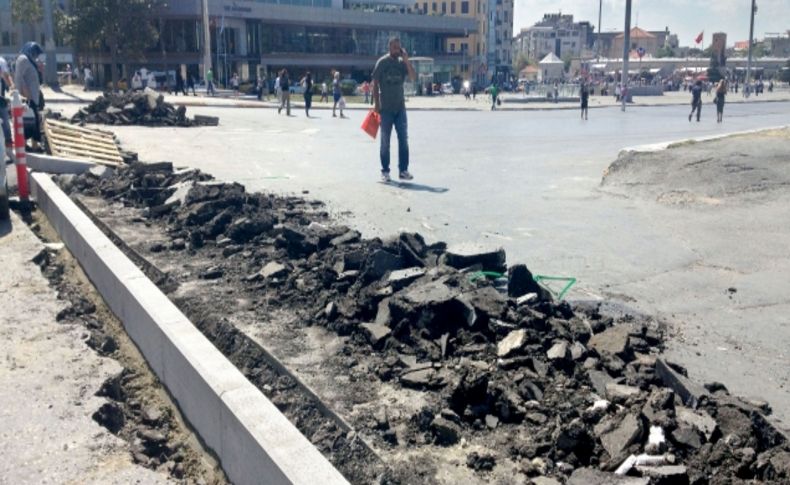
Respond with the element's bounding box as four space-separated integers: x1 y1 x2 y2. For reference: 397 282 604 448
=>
54 98 790 421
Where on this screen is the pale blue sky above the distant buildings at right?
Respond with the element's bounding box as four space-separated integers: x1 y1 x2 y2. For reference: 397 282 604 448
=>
513 0 790 47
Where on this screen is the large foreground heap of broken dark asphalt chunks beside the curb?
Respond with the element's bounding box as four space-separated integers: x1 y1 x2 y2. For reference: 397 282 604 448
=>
61 163 790 485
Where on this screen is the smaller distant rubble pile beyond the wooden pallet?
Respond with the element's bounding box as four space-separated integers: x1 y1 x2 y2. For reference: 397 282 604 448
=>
71 88 219 126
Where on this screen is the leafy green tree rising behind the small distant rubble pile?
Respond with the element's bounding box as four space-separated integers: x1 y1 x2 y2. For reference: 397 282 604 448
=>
60 0 163 89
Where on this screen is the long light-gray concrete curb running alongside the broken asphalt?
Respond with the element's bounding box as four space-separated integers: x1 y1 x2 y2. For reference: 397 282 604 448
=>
30 173 348 485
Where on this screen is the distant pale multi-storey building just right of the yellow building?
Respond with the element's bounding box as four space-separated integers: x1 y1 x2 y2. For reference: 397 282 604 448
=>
513 13 595 62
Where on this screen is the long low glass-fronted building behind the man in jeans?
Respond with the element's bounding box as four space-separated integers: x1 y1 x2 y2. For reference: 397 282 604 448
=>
0 0 477 85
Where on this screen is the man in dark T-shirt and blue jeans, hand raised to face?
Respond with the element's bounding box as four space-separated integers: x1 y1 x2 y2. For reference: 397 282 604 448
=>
373 37 417 182
